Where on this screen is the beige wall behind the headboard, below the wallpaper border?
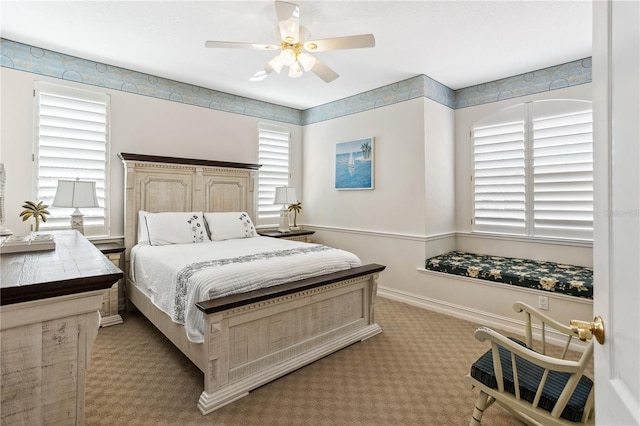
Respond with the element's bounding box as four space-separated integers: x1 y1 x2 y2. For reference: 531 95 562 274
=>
0 68 302 237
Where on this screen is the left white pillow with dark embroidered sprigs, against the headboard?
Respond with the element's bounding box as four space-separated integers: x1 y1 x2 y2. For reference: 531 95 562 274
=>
144 212 209 246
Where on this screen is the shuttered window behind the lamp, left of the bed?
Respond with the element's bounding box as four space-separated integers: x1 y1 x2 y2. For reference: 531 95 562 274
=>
33 82 109 236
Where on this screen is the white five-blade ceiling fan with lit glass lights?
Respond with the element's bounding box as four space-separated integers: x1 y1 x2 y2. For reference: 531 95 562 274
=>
204 1 376 83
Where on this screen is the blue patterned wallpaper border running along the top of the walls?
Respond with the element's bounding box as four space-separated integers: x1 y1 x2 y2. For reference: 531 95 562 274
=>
0 39 591 126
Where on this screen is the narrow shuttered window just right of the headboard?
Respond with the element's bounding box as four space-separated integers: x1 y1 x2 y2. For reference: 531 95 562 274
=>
258 124 290 225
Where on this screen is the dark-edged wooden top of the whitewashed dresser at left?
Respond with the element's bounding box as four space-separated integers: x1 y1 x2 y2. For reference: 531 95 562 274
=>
0 230 123 305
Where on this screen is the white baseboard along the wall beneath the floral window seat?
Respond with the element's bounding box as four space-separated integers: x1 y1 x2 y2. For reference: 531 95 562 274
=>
378 286 585 352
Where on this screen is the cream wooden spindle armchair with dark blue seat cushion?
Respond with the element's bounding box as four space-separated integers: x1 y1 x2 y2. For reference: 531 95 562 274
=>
465 302 595 426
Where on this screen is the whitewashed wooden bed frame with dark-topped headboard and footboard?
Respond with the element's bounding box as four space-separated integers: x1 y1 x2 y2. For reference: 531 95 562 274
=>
119 153 385 414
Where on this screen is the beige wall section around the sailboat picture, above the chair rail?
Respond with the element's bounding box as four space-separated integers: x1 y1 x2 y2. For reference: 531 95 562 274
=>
302 99 424 234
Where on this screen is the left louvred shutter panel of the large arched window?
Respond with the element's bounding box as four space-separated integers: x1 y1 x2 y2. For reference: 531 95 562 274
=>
473 121 526 234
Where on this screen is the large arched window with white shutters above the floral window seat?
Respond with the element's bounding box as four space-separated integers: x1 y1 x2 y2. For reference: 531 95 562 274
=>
472 101 593 239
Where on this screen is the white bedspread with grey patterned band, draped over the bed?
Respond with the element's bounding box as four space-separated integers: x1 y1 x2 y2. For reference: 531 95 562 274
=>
130 237 360 343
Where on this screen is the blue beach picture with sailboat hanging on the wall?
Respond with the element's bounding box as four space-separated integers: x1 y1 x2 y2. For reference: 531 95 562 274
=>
335 137 373 189
